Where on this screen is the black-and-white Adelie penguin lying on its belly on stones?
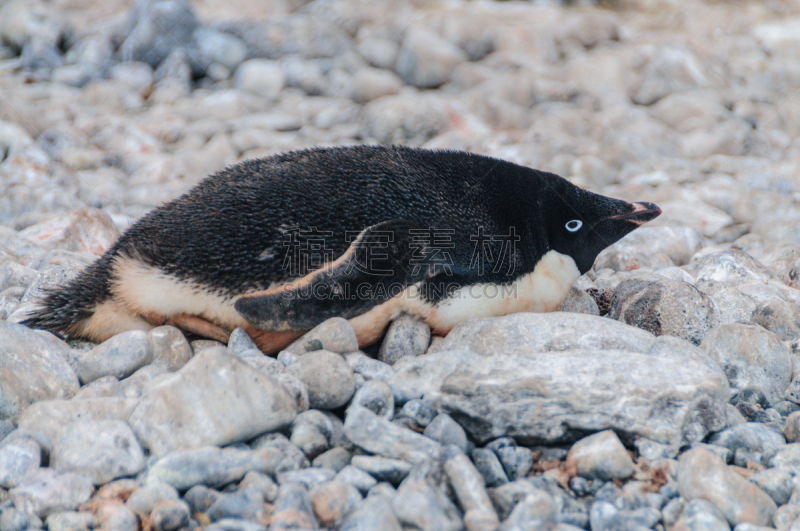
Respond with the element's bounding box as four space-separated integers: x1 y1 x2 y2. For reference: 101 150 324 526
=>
26 146 661 353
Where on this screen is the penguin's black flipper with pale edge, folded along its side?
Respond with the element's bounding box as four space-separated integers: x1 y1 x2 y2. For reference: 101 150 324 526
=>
234 220 441 332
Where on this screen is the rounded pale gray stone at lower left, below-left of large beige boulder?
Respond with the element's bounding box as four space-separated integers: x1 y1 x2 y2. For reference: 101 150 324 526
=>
50 419 145 485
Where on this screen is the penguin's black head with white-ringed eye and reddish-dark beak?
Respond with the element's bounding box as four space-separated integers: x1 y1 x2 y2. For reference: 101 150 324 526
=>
542 178 661 274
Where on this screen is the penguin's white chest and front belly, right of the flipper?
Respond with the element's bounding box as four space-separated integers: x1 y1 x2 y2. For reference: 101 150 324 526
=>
350 251 580 345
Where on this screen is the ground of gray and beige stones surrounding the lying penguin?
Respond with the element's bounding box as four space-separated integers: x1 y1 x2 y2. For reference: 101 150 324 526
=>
0 0 800 531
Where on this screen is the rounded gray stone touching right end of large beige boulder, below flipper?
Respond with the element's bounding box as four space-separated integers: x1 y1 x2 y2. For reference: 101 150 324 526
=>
286 352 355 409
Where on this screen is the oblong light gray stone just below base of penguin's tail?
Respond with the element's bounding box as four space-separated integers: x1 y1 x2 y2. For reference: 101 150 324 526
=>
77 330 153 384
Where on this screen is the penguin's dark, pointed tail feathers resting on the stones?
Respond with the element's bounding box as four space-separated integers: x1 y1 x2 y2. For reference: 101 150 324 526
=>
21 253 114 339
